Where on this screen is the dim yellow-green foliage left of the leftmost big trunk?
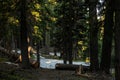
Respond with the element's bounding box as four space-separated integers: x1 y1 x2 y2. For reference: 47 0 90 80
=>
0 0 20 48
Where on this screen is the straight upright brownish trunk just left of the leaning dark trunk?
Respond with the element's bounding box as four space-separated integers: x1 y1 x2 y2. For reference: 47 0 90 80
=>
89 1 99 71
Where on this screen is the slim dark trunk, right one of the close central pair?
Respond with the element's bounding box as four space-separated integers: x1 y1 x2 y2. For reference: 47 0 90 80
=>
67 0 73 64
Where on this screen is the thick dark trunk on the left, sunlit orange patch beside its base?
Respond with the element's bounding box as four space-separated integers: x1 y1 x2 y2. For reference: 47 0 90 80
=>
20 0 30 68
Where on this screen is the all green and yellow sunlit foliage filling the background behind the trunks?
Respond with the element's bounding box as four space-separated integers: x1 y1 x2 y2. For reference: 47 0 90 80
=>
0 0 106 61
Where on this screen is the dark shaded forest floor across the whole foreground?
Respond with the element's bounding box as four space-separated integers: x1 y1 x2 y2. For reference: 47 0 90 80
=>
0 57 114 80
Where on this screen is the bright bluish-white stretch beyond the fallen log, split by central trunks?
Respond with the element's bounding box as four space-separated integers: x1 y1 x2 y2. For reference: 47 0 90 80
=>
40 57 90 69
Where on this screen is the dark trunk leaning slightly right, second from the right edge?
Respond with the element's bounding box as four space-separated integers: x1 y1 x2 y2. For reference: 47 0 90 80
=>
100 0 113 73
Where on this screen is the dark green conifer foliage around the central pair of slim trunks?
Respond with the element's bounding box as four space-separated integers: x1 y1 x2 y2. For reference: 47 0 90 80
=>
52 0 89 59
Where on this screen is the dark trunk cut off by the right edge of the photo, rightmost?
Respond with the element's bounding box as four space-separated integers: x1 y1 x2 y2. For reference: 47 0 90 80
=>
115 9 120 80
